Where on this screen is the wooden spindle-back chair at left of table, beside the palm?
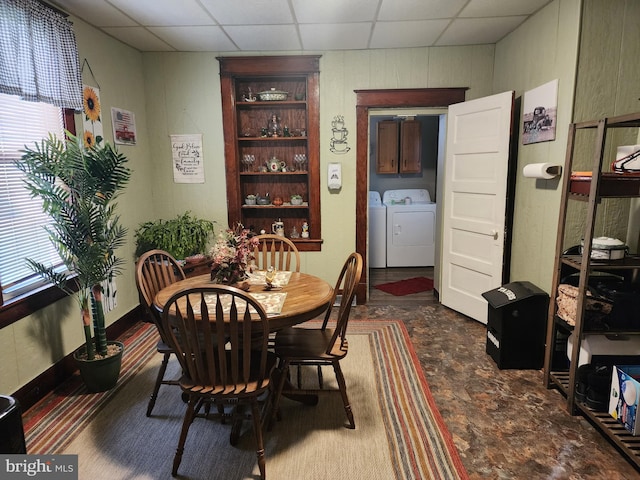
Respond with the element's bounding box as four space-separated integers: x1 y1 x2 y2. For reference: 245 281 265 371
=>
136 250 185 417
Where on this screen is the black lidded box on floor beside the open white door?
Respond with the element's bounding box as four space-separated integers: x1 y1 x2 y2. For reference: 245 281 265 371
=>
482 282 549 370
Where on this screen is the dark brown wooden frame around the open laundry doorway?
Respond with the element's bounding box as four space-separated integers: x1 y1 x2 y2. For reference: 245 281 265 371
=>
354 87 469 304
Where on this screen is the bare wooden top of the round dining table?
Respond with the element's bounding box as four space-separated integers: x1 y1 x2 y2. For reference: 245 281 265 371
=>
153 272 333 331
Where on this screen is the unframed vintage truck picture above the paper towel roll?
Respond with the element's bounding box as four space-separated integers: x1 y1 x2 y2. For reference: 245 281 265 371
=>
522 79 558 145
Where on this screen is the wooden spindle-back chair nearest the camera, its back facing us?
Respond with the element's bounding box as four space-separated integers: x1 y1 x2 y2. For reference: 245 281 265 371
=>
162 284 277 479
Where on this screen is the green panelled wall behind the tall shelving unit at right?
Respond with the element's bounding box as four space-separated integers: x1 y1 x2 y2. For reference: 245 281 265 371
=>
565 0 640 252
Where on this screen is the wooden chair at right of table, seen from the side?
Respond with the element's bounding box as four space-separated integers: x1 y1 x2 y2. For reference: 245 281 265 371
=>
269 252 362 428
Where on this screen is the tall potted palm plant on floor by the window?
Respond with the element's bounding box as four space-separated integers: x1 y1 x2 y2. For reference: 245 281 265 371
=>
17 132 131 391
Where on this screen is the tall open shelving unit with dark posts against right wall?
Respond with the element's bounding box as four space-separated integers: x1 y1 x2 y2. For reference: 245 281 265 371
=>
544 113 640 468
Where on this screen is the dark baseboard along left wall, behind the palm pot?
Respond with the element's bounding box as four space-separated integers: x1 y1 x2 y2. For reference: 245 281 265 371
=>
13 306 144 412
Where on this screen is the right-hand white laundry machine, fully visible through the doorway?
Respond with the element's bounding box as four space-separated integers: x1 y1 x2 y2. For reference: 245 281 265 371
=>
382 188 436 267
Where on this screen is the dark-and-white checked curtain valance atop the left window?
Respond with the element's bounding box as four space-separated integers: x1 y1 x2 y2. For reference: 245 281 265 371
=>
0 0 82 111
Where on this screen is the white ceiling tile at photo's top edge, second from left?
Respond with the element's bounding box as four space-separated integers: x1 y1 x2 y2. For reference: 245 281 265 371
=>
109 0 215 27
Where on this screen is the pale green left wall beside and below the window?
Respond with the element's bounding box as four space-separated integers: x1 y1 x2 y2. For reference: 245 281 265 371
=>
0 19 154 394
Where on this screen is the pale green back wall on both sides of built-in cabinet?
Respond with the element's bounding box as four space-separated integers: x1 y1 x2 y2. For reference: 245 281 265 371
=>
144 45 494 283
